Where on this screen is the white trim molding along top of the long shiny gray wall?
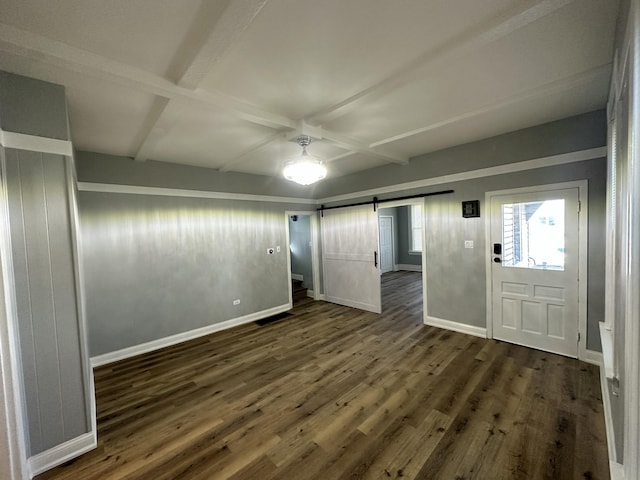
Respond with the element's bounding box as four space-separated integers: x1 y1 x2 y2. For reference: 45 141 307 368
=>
78 182 317 205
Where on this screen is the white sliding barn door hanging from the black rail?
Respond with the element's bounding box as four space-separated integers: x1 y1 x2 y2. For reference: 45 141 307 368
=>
322 205 382 313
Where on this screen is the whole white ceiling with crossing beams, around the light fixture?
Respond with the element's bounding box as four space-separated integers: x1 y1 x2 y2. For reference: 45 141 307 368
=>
0 0 618 180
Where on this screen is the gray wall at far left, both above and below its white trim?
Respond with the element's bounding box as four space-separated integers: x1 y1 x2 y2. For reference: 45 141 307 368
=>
0 68 91 456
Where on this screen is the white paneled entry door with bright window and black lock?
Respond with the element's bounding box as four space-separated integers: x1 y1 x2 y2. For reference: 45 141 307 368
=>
490 188 579 357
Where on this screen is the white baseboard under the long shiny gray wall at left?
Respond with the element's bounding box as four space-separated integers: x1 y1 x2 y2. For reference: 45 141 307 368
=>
91 303 292 368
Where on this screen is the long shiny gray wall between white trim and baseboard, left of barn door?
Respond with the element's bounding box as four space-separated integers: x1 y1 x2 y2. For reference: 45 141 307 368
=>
79 192 304 356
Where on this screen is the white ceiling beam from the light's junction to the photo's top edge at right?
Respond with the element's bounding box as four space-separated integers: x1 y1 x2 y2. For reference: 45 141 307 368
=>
306 0 575 125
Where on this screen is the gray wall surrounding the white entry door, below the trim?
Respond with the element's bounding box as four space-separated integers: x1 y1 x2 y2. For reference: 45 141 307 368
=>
425 159 606 351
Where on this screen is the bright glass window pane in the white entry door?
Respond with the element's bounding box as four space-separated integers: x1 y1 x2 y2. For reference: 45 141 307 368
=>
502 199 565 270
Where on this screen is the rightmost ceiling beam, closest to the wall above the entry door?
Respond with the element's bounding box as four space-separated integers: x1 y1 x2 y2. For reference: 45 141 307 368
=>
370 63 612 147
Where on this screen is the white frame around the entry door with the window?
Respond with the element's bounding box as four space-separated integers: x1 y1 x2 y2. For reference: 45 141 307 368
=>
485 180 589 360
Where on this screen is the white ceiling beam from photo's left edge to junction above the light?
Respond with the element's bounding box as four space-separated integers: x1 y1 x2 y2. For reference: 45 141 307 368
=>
0 24 297 129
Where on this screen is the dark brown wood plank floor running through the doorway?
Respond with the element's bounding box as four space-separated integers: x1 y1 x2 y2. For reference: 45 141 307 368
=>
38 273 609 480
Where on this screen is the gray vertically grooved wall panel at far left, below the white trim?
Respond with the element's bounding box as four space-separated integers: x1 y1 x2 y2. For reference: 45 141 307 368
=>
6 149 90 455
